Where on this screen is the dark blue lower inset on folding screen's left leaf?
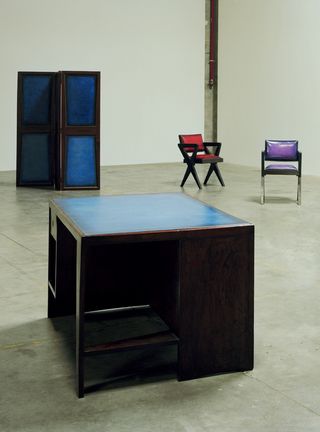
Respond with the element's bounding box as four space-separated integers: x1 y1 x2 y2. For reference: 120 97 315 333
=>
20 133 51 183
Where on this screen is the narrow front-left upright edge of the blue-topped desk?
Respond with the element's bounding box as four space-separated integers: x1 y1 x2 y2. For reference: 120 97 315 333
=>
76 239 86 398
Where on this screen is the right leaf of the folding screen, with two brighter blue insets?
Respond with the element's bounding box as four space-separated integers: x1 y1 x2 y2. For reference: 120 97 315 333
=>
56 72 100 189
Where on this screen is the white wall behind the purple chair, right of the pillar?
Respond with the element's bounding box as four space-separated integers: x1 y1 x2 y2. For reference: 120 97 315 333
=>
218 0 320 175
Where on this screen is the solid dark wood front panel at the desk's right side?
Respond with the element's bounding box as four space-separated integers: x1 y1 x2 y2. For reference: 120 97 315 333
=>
178 231 253 380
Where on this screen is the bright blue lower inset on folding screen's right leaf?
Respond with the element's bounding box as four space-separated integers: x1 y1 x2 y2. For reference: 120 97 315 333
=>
65 136 97 187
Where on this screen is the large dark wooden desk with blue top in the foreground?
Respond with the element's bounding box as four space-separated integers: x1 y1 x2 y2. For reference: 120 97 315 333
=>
48 193 254 397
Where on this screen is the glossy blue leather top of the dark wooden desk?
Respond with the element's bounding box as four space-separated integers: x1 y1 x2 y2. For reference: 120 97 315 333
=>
53 193 250 236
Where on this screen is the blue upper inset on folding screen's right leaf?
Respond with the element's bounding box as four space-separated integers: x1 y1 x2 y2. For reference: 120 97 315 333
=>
66 75 96 126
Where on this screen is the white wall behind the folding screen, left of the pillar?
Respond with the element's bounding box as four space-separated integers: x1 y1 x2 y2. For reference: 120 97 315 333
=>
0 0 205 170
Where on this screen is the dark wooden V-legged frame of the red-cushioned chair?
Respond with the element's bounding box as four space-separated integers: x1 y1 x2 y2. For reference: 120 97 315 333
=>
178 140 225 189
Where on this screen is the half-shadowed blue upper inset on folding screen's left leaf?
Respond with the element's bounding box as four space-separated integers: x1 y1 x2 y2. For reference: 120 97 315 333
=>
22 75 52 125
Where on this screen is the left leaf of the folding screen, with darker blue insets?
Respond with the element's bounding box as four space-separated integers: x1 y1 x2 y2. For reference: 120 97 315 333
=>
16 72 56 186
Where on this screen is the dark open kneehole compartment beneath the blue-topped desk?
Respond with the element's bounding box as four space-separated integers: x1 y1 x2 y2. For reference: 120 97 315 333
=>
85 241 179 366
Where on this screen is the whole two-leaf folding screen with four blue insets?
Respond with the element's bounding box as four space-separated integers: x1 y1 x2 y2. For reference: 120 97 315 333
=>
17 72 100 190
